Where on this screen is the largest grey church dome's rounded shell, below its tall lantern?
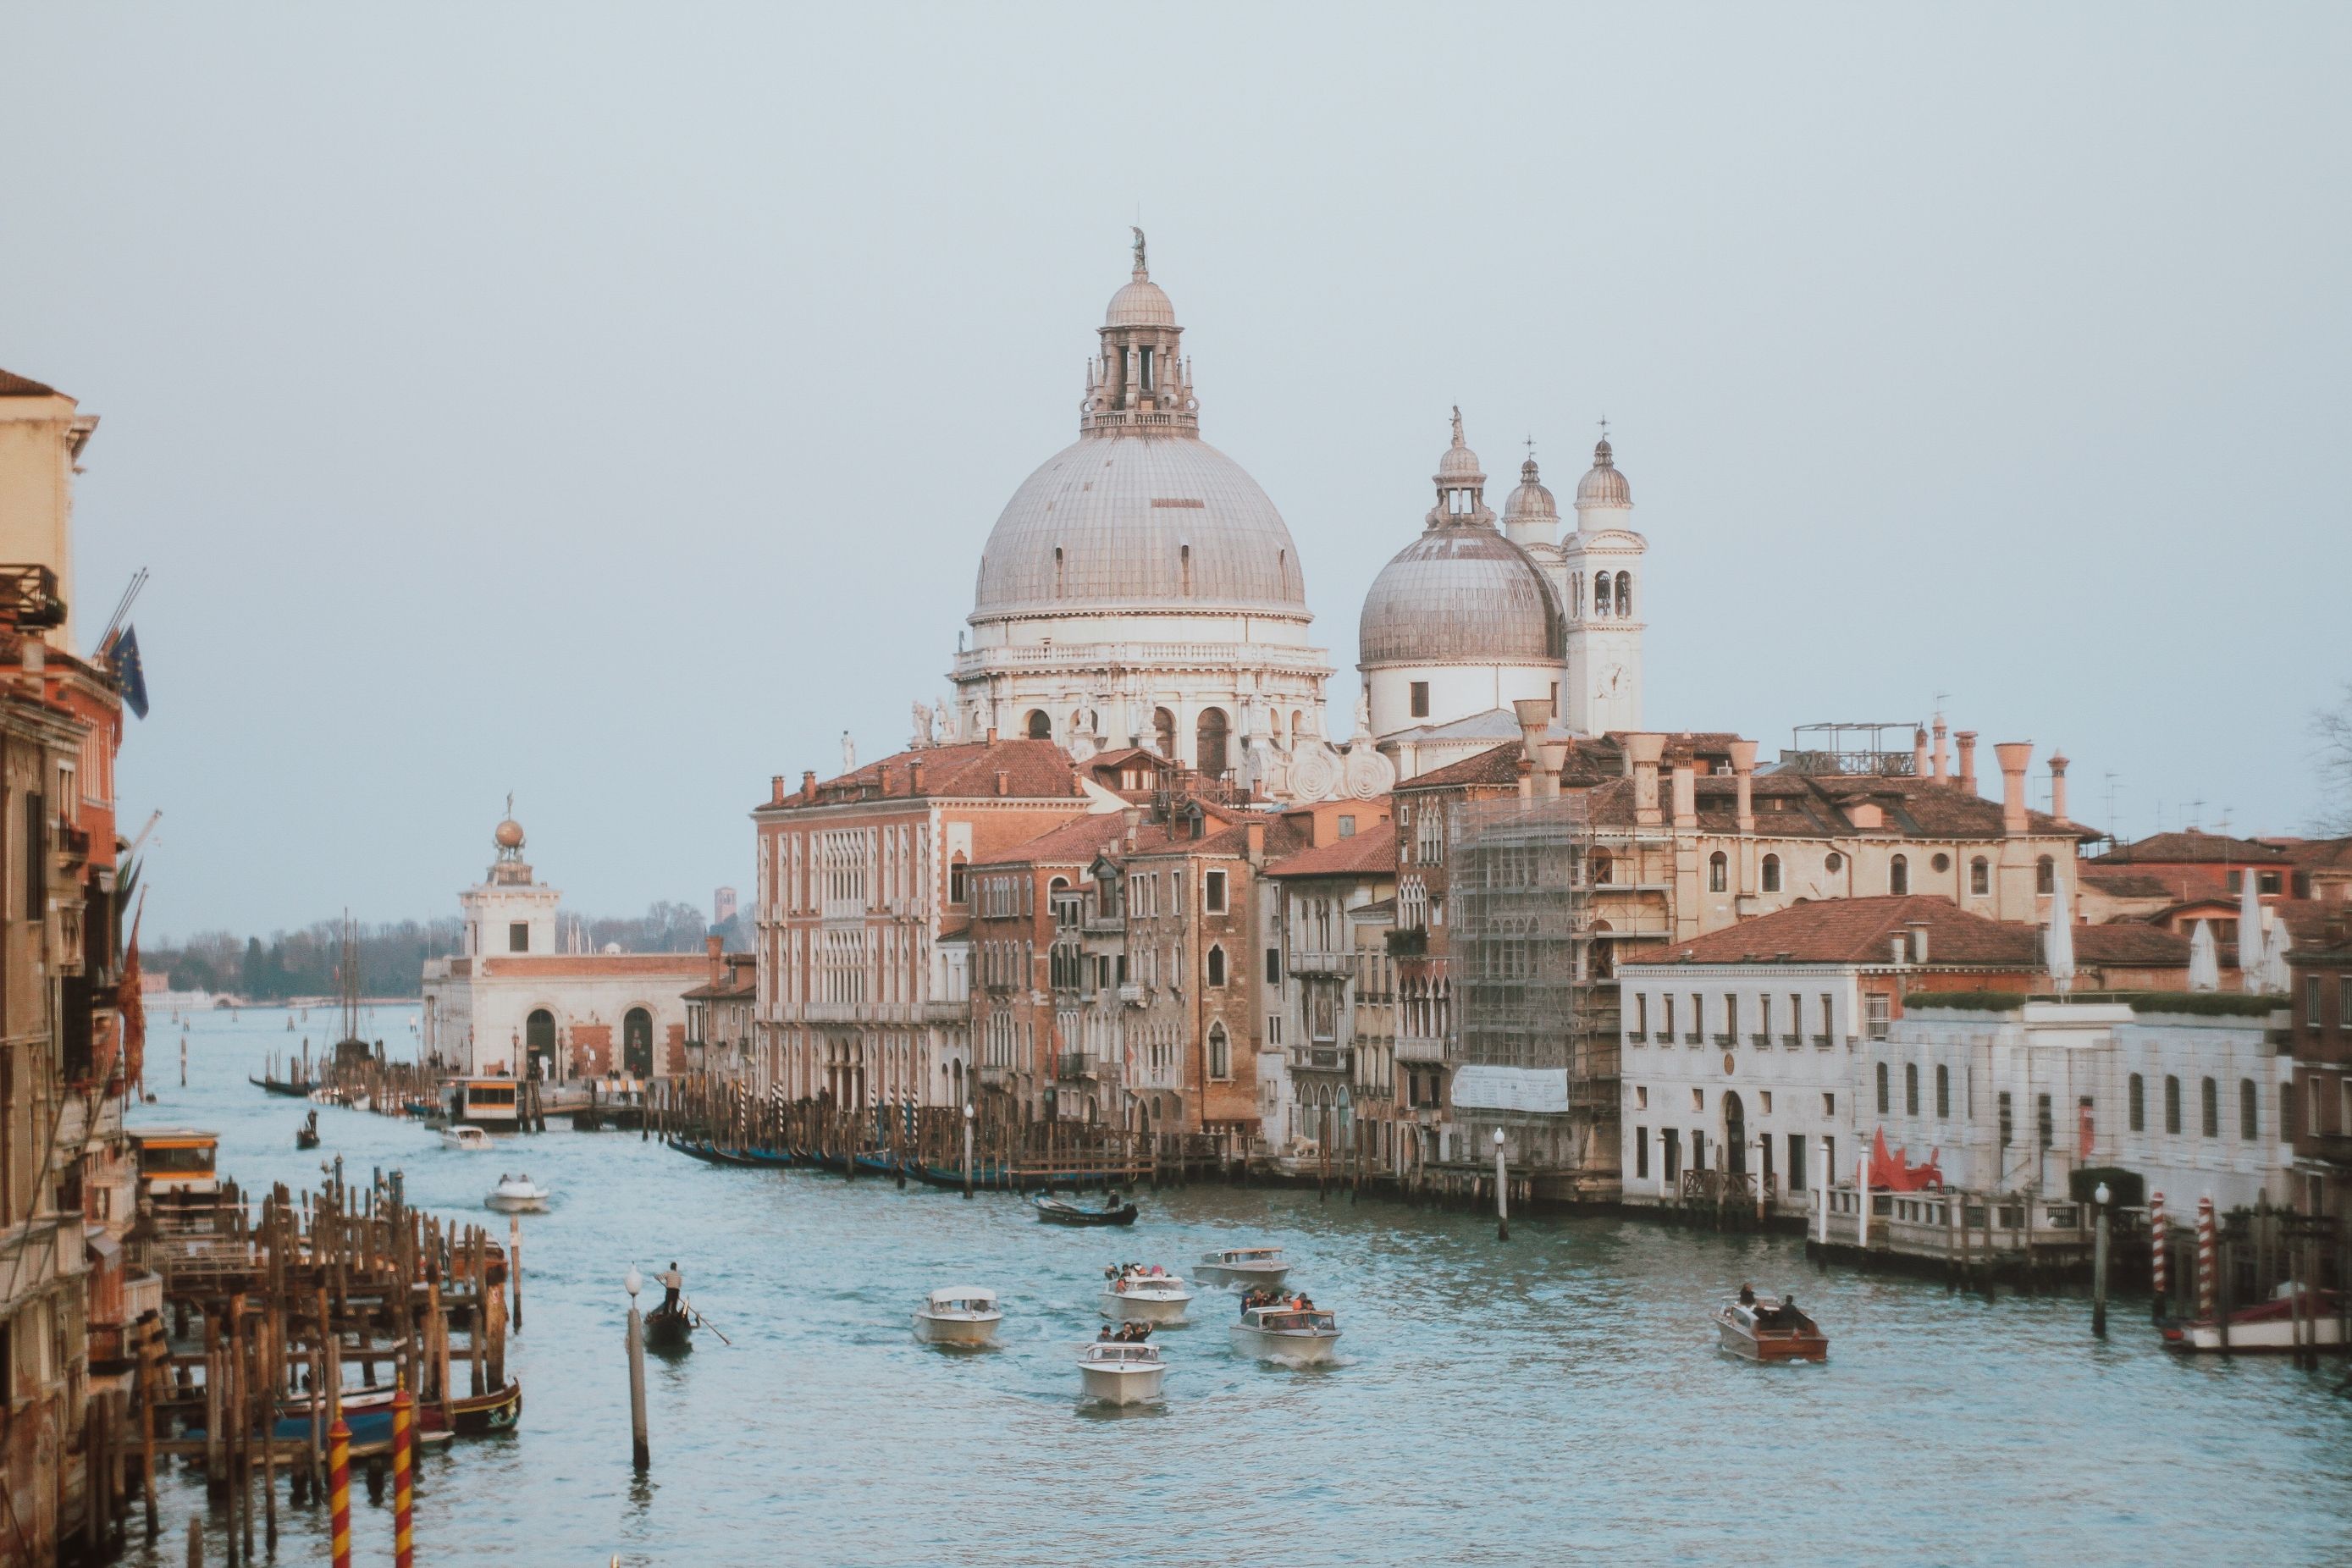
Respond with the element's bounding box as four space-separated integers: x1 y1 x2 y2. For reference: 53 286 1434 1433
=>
971 435 1308 621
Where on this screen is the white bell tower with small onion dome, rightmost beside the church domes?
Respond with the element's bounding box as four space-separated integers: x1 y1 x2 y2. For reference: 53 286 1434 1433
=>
1560 428 1648 736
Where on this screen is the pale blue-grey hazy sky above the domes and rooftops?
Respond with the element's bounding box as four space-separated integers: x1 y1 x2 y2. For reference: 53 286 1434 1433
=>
0 5 2352 933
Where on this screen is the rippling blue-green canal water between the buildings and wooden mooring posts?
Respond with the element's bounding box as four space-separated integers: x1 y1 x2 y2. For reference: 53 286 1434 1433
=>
134 1008 2352 1568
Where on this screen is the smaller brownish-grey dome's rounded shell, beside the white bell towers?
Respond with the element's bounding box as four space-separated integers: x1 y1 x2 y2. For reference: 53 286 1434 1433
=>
1357 522 1566 670
